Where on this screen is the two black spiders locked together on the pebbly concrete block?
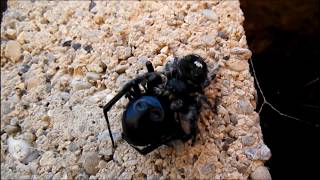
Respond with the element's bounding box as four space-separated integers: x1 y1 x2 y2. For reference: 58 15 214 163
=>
103 54 216 154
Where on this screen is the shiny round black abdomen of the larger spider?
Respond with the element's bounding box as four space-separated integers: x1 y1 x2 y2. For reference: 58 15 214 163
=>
122 96 177 146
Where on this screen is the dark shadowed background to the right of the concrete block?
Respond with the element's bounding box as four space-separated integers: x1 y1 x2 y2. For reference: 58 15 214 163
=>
240 0 320 179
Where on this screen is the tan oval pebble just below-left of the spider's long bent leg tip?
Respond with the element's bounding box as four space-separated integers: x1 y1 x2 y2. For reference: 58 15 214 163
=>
82 152 100 175
